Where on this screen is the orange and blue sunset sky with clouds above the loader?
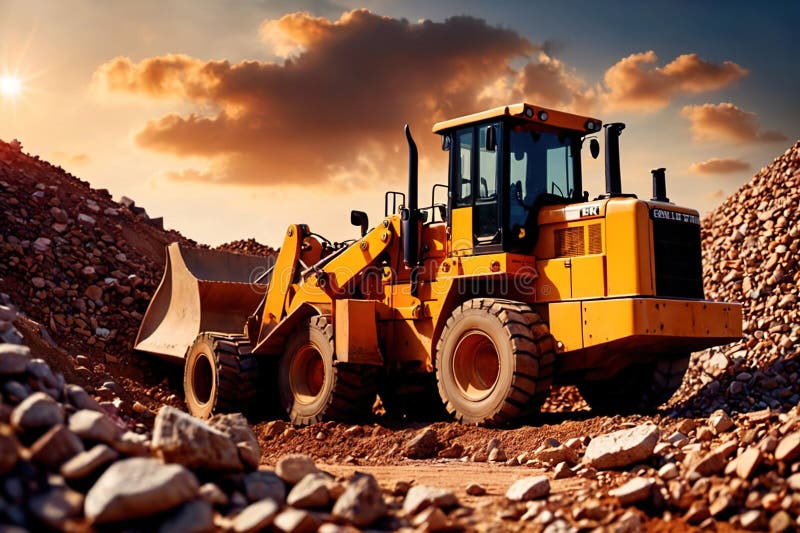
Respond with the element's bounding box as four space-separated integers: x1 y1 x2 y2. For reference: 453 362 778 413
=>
0 0 800 247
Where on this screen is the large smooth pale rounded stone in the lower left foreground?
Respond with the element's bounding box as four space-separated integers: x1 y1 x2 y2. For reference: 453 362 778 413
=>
84 457 200 524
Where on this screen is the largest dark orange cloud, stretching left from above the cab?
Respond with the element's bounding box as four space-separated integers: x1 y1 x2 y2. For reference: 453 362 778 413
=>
94 10 539 185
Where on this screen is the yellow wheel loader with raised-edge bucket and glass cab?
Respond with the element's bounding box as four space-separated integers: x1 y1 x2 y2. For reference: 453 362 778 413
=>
135 103 742 425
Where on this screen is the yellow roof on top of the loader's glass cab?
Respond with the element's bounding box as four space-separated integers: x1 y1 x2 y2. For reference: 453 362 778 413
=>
433 102 602 134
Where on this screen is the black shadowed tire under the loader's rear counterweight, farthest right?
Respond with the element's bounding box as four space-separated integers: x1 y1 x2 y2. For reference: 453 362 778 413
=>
578 353 690 413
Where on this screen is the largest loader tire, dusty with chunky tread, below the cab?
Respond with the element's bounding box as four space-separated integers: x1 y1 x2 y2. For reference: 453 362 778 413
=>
436 298 555 426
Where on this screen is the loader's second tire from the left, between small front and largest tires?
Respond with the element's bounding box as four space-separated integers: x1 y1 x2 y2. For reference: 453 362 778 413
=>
278 316 380 426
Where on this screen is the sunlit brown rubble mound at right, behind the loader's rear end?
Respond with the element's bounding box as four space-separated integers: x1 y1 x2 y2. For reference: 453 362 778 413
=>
673 141 800 414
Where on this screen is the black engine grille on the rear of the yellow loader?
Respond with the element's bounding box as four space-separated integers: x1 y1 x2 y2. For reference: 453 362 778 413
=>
652 219 704 299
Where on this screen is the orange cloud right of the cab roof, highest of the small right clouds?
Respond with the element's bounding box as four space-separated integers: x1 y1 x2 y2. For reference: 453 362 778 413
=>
603 50 748 111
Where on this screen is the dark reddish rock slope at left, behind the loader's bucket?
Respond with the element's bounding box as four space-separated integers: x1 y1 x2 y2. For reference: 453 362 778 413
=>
0 137 193 354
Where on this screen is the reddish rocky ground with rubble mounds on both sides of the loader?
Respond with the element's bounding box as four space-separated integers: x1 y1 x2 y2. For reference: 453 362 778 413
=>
0 135 800 533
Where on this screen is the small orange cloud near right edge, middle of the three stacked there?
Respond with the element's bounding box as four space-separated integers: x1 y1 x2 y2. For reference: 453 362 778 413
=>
681 102 786 143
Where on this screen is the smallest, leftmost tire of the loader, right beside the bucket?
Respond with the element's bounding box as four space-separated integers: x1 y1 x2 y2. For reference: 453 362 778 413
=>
183 332 258 418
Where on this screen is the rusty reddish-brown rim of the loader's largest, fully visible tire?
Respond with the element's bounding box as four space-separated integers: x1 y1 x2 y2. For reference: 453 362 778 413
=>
453 330 500 402
